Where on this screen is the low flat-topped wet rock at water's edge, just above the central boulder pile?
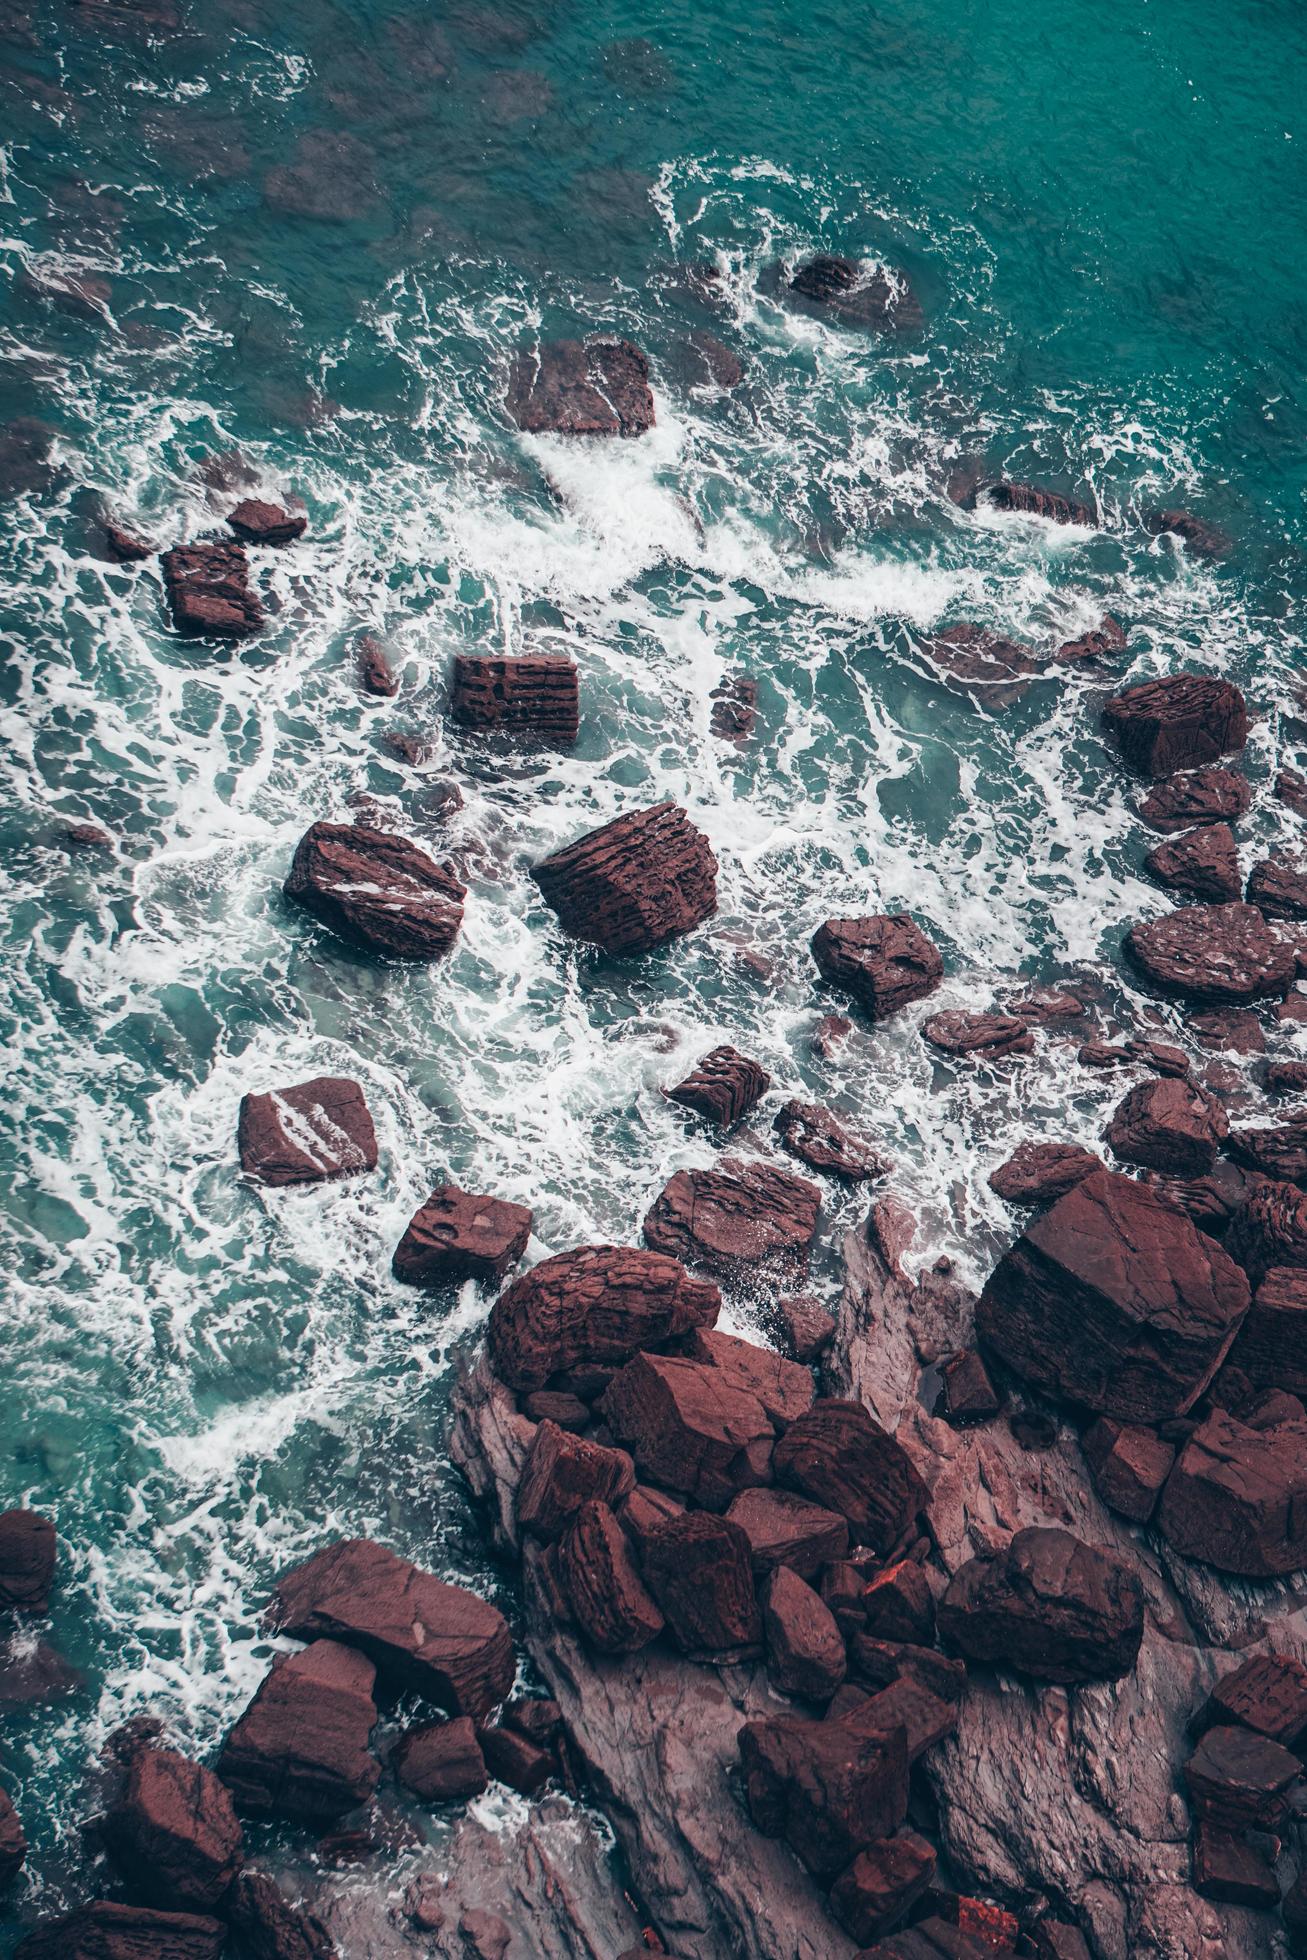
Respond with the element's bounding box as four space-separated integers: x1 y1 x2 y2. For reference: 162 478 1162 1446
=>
645 1158 821 1278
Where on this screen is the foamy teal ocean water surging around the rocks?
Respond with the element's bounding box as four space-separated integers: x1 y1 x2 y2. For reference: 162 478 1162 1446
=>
0 0 1307 1952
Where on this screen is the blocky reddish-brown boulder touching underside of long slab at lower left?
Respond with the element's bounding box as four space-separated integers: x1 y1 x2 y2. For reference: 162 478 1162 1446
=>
218 1641 382 1821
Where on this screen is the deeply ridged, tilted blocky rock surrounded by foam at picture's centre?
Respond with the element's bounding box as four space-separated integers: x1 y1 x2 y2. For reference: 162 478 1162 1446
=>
531 804 717 955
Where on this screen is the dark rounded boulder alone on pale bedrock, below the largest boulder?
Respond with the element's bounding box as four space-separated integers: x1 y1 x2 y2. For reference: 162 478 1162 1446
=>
939 1527 1144 1684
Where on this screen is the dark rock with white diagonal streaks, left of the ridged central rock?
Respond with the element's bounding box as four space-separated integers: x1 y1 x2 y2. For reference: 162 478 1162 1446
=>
282 823 466 960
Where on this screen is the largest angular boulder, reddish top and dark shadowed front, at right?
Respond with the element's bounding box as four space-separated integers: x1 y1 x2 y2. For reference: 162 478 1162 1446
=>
976 1170 1248 1423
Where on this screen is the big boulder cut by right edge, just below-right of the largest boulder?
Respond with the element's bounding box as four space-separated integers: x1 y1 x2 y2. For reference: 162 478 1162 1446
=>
1156 1409 1307 1578
